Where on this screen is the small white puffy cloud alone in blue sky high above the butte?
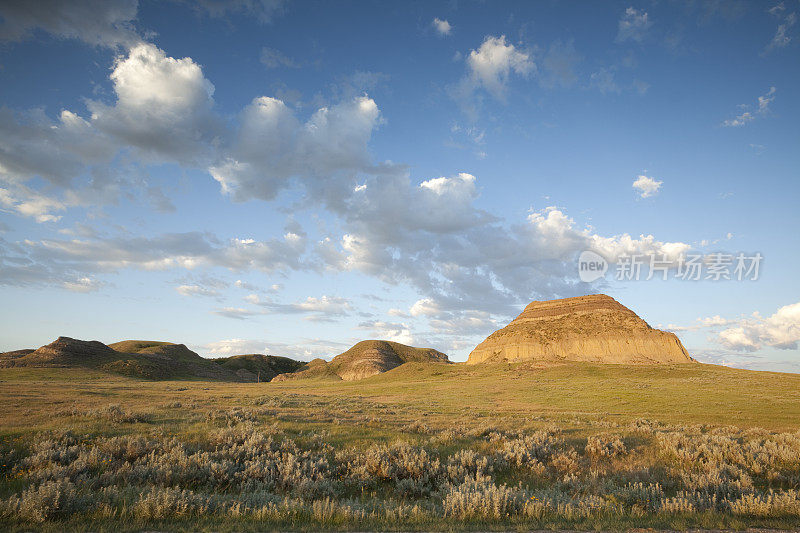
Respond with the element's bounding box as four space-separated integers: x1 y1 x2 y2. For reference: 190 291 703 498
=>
467 35 536 100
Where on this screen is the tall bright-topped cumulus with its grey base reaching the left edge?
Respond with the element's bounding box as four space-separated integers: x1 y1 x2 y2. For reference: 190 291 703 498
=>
0 43 220 216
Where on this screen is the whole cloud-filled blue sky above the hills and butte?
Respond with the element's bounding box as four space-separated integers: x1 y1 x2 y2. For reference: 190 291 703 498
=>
0 0 800 371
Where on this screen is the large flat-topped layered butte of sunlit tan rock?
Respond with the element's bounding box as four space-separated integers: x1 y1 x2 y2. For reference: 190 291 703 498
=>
467 294 693 364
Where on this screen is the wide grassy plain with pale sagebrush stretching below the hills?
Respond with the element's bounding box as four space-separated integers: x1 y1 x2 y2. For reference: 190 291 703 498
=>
0 363 800 531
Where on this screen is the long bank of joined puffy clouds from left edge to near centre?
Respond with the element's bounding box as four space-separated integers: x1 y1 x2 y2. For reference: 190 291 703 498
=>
0 43 391 221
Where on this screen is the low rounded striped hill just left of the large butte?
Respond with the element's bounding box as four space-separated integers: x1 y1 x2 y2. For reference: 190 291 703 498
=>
275 340 449 381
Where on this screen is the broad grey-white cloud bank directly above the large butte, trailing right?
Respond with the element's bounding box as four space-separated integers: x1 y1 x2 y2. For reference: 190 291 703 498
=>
316 168 689 316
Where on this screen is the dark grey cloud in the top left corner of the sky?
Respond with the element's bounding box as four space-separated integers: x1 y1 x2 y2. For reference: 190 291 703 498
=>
0 0 140 47
